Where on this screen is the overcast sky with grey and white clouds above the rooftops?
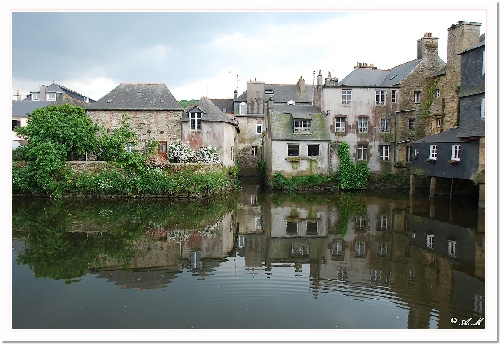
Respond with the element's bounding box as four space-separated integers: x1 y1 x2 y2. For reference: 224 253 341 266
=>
7 3 494 100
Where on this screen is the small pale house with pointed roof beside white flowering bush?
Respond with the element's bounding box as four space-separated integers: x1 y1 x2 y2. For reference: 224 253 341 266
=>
181 97 239 166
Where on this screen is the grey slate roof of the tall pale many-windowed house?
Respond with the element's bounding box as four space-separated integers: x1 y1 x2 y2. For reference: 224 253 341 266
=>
339 60 422 87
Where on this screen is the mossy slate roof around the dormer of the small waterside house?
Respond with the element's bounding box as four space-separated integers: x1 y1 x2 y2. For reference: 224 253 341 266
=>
269 104 330 141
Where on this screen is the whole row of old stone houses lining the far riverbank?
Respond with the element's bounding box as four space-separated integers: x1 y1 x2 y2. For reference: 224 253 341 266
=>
13 21 485 206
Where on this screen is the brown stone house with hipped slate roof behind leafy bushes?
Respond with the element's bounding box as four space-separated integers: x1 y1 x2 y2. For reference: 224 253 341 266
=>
87 83 183 155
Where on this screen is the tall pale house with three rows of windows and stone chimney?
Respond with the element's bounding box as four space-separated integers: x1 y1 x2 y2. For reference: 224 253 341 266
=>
315 29 444 172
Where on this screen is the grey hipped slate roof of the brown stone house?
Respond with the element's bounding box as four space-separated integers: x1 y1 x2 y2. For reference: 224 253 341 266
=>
88 83 181 110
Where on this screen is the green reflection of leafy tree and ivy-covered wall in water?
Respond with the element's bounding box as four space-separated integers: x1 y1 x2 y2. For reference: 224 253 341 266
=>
12 197 235 283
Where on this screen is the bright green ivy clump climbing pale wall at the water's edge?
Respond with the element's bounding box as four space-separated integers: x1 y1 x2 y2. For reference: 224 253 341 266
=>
336 142 370 190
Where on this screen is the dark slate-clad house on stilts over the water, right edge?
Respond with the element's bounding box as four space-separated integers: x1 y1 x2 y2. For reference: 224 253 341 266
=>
411 35 486 207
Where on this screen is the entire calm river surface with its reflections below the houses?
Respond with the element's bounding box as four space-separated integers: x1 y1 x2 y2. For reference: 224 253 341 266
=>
12 184 487 340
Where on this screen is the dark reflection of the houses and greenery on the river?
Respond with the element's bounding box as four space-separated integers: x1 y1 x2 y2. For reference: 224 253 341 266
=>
12 184 485 329
